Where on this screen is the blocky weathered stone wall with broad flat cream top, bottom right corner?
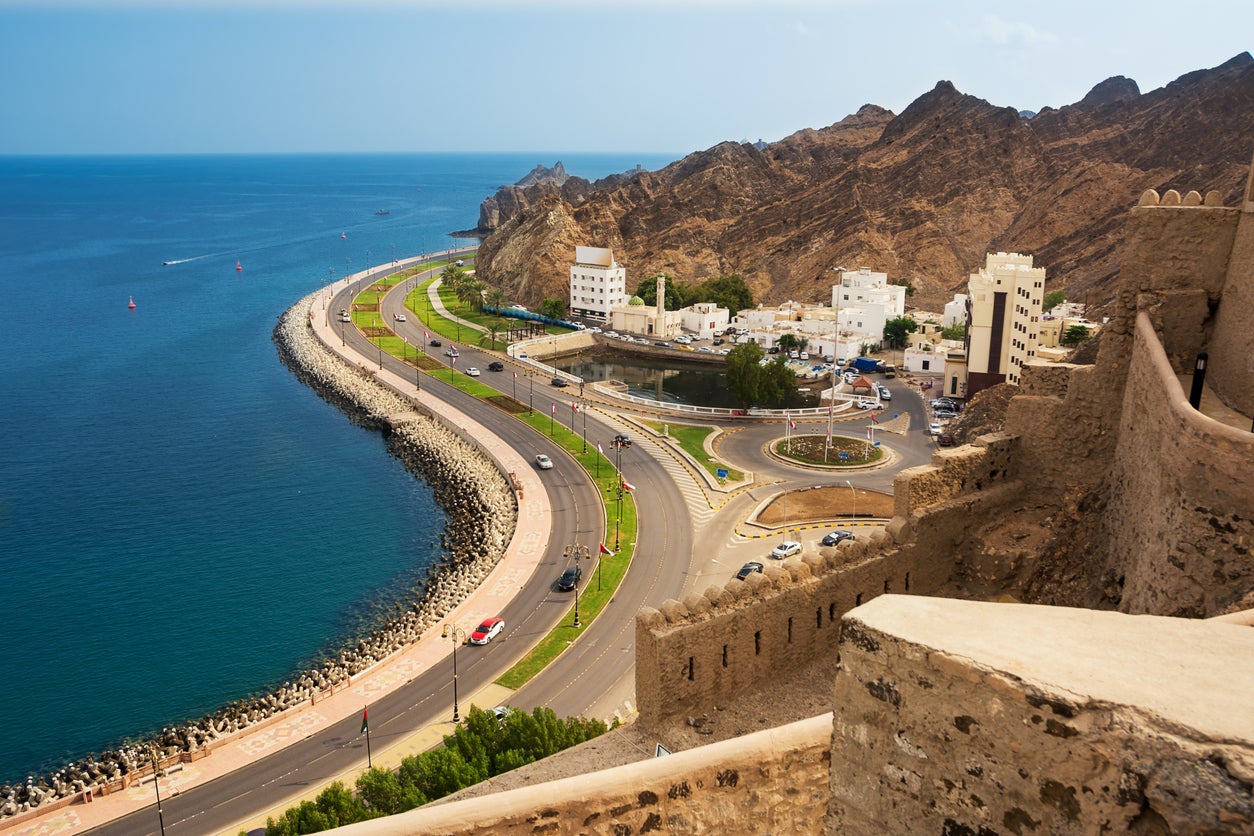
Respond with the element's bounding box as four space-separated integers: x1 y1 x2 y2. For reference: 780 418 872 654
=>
828 595 1254 835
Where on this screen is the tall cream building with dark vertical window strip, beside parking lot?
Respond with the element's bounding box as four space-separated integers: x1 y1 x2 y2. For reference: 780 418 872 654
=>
966 252 1045 397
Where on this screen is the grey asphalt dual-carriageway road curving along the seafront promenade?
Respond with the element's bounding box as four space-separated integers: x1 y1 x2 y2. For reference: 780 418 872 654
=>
92 261 692 836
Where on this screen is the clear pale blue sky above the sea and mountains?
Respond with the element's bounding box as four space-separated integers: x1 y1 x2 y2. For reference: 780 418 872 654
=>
0 0 1254 154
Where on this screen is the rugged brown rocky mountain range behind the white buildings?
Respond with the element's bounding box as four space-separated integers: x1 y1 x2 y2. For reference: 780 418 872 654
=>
477 53 1254 312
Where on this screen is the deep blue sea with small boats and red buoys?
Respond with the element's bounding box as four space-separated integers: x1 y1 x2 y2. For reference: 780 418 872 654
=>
0 153 675 783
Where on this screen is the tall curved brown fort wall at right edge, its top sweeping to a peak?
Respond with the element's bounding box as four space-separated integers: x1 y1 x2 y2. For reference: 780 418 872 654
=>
1102 313 1254 617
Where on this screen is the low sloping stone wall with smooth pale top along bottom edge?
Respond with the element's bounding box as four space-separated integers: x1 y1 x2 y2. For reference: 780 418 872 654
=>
336 714 831 836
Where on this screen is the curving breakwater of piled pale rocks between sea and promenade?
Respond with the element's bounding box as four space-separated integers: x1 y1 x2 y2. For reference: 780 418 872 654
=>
0 297 518 821
